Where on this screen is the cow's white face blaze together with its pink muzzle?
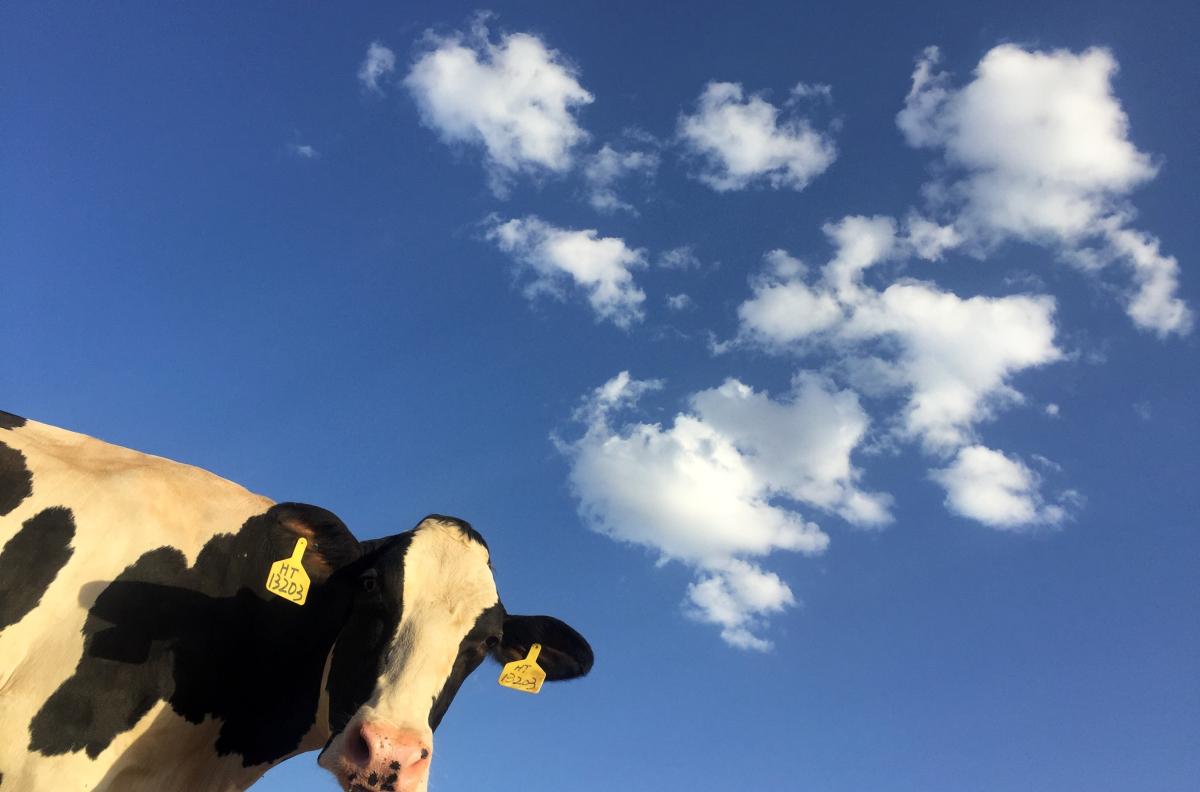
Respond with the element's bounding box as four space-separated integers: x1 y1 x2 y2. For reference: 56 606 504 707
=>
318 518 499 792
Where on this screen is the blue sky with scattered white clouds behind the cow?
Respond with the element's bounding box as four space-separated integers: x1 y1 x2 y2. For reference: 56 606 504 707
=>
0 2 1200 792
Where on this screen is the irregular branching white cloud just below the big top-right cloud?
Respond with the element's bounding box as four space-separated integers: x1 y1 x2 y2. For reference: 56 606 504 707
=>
738 217 1062 452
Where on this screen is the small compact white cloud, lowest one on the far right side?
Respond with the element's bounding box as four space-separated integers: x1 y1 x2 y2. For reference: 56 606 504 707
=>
930 445 1076 530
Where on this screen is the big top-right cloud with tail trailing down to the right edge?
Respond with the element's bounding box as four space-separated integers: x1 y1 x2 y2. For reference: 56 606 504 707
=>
896 44 1192 336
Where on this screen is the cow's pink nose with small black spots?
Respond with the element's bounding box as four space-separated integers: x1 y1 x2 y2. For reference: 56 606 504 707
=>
346 721 432 792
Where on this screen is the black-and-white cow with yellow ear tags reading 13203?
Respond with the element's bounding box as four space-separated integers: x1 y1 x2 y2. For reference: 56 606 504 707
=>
0 413 593 792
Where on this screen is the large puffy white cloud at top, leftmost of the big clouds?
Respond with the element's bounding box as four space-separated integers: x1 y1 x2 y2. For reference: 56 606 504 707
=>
404 17 593 193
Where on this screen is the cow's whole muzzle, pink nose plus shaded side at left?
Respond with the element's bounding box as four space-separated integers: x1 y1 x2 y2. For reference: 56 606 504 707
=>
318 720 433 792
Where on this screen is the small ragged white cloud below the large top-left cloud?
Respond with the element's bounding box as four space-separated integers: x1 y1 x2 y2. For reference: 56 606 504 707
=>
487 216 646 328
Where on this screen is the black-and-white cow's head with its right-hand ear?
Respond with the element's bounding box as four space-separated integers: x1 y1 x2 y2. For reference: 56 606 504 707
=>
318 515 592 792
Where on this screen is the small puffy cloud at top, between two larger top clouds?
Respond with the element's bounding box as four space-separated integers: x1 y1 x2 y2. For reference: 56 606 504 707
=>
678 83 838 192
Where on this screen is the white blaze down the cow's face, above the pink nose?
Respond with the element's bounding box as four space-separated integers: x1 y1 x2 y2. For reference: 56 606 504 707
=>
368 520 499 733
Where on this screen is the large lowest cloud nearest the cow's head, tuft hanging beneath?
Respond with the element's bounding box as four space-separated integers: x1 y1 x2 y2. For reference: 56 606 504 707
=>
564 372 890 649
